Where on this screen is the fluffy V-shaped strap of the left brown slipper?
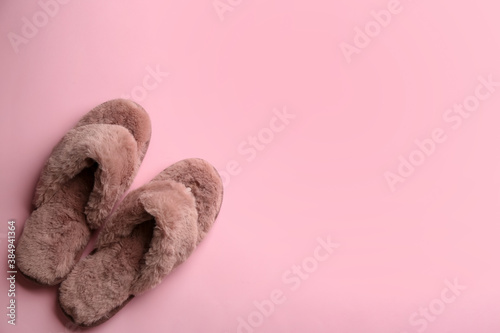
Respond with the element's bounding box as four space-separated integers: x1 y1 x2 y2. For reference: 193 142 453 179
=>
33 124 140 229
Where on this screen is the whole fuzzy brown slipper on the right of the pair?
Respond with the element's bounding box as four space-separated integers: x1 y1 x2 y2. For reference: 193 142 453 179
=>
58 159 222 326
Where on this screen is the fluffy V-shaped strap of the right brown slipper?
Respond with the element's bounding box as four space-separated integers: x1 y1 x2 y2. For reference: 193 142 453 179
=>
97 180 199 295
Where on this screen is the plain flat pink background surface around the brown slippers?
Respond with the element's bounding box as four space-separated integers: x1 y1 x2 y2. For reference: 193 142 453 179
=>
0 0 500 333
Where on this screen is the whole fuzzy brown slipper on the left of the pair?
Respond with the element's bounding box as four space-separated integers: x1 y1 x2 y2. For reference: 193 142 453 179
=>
16 99 151 285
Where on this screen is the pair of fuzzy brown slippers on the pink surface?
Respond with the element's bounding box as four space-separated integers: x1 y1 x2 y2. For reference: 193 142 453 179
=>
17 99 223 326
